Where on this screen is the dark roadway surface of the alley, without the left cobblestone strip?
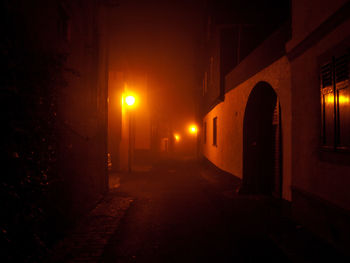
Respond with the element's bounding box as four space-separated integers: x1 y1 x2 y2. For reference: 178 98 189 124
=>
100 162 289 262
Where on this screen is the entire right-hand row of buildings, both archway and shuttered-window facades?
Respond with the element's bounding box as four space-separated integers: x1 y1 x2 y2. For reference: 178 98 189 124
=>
201 0 350 254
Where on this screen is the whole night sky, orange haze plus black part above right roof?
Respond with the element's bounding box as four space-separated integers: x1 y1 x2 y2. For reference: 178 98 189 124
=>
109 0 288 125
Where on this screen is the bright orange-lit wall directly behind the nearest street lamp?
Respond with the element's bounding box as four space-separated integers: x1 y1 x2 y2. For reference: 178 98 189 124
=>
108 70 151 171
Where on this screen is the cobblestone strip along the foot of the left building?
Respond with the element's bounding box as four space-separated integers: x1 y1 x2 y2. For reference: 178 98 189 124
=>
46 190 133 263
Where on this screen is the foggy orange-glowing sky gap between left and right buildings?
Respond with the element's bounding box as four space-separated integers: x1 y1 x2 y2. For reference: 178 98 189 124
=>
106 1 205 127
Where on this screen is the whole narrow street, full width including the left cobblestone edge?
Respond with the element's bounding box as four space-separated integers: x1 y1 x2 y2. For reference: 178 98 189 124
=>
50 161 345 262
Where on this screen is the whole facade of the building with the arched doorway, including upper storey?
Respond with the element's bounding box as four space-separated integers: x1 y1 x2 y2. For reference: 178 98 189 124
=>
202 1 291 200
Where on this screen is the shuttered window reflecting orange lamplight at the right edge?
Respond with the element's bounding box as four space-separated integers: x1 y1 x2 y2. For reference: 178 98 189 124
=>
320 51 350 151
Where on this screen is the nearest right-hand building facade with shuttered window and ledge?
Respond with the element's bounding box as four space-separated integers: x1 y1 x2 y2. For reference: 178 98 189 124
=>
286 1 350 253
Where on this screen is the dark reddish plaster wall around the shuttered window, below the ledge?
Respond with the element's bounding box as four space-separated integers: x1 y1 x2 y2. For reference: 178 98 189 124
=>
291 20 350 209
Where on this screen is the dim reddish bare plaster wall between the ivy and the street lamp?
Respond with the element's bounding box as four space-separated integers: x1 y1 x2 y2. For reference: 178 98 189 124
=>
57 1 108 220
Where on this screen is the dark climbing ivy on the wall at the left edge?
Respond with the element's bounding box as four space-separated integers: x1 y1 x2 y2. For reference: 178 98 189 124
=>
0 3 66 262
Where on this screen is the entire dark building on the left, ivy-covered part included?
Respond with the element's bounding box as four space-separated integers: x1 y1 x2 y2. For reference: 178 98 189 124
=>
1 0 113 262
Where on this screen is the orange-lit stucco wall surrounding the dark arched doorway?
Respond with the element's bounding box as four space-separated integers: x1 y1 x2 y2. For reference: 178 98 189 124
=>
202 57 291 200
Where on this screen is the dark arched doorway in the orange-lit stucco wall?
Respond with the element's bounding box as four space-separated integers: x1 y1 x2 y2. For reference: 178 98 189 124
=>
241 82 282 198
